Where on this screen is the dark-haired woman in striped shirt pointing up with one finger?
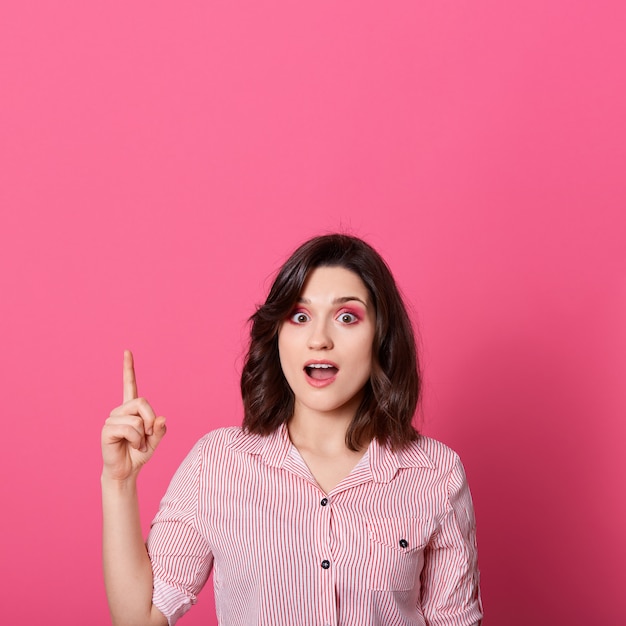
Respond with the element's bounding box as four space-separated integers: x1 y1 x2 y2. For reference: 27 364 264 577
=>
102 235 482 626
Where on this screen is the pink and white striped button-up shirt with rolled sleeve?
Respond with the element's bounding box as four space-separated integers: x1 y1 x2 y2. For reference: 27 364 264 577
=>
147 426 482 626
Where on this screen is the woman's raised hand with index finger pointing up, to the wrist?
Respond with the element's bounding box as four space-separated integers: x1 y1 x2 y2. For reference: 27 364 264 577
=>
102 350 165 482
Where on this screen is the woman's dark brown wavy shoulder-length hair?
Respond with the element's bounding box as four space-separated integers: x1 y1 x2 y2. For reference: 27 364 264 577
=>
241 234 421 450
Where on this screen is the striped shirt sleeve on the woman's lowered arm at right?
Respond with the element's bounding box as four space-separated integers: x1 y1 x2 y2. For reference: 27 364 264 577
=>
421 457 483 626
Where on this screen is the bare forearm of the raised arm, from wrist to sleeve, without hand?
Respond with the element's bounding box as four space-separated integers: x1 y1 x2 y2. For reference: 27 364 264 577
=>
102 477 167 626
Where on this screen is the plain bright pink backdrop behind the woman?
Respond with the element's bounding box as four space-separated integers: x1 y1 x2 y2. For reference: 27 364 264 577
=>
0 0 626 626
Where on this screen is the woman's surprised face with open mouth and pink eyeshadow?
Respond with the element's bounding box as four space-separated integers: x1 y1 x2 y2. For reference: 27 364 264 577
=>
278 267 376 419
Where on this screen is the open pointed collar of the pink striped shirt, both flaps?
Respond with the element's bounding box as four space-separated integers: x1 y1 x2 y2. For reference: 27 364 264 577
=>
228 424 436 483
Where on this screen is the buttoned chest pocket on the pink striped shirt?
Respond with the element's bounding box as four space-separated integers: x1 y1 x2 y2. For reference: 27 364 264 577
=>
368 517 434 591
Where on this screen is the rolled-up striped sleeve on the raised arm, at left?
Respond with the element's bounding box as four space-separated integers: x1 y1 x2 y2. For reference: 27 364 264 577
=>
146 439 213 626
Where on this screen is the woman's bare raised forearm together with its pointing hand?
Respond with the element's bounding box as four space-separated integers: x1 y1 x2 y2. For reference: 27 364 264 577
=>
102 351 167 626
